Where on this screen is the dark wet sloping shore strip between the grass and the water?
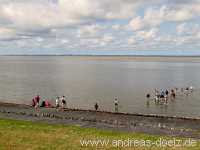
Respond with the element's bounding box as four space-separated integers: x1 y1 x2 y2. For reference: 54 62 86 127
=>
0 103 200 139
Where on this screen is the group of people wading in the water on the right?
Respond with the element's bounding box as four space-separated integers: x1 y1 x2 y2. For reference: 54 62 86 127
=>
146 86 193 105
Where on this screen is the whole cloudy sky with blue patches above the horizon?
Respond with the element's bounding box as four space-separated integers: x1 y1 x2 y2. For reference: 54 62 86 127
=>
0 0 200 54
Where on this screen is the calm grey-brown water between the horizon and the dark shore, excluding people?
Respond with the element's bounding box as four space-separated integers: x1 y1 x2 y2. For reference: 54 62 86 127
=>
0 56 200 116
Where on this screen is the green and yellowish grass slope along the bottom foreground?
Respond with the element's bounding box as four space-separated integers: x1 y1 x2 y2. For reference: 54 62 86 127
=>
0 119 200 150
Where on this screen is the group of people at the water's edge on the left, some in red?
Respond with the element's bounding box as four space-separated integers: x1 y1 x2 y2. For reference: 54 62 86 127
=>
31 95 66 109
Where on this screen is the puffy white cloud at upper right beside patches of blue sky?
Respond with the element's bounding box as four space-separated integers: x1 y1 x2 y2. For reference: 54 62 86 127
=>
129 5 194 31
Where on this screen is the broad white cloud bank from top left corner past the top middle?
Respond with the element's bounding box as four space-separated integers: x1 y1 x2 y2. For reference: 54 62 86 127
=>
0 0 148 29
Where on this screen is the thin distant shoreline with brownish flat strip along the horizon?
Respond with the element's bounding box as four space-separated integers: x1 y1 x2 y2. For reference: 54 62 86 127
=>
0 55 200 63
